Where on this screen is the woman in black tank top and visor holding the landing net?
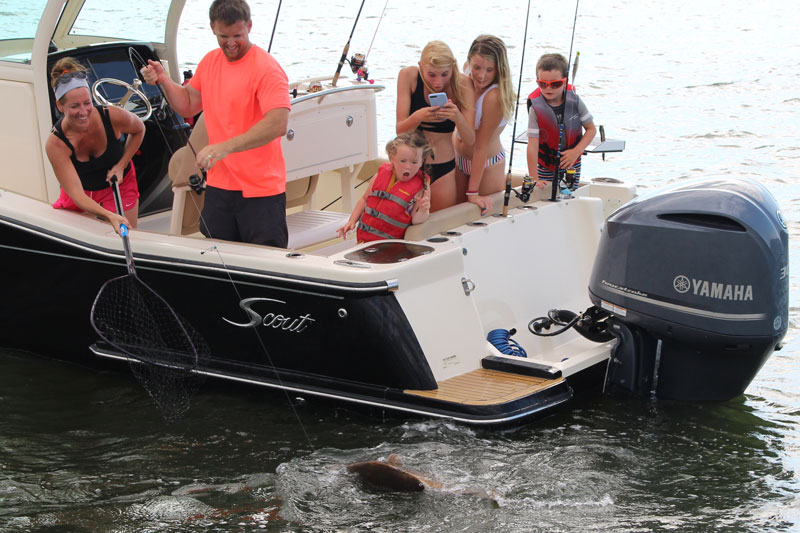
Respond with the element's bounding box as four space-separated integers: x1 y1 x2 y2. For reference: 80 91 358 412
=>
45 58 145 232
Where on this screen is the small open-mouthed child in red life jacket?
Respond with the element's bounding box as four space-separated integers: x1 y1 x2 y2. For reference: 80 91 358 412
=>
337 131 431 242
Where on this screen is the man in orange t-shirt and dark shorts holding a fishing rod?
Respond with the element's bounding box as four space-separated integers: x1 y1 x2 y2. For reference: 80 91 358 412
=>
142 0 291 248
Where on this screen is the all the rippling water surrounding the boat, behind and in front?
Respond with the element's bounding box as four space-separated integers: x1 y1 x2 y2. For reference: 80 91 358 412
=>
0 0 800 532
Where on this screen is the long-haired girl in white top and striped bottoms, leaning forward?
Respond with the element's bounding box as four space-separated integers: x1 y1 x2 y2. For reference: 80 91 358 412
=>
455 35 516 214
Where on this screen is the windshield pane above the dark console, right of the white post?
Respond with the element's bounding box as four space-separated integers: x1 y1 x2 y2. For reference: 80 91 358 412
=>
69 0 171 43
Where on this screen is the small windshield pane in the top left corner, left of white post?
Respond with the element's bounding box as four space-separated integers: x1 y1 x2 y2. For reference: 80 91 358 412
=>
0 0 47 63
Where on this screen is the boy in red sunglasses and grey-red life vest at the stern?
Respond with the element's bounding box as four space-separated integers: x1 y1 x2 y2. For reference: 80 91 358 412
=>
527 54 597 190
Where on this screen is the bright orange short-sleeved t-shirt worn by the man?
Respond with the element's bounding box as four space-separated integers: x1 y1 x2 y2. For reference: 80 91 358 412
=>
189 45 292 198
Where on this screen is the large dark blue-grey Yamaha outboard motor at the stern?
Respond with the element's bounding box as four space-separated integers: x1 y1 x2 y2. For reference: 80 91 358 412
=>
589 179 789 400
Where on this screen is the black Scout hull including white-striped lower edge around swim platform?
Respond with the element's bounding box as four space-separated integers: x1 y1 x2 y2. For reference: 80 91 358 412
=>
0 210 596 426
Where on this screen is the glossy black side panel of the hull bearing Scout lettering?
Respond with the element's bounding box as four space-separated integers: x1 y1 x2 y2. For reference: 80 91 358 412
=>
0 214 436 389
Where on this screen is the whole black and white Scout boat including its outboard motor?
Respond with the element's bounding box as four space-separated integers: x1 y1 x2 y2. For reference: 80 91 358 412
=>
0 0 788 425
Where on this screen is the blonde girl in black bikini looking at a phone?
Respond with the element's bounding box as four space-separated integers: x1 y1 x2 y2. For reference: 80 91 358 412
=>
396 41 475 211
